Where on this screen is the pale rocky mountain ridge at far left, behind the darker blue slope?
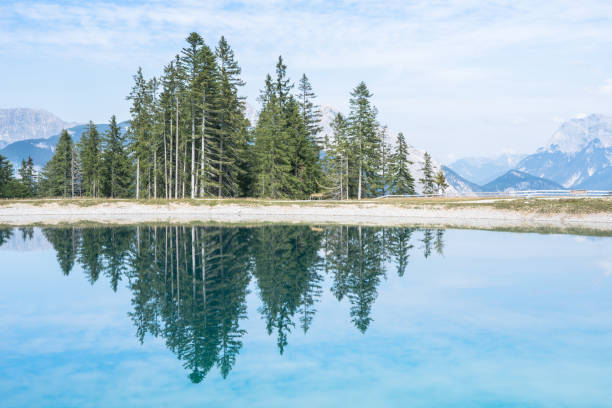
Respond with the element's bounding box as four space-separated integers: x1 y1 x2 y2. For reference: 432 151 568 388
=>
0 108 76 148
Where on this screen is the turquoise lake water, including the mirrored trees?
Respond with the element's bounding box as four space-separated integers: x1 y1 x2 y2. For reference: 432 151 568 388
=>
0 226 612 407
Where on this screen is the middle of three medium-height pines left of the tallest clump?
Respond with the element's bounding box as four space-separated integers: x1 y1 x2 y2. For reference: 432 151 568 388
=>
79 121 102 197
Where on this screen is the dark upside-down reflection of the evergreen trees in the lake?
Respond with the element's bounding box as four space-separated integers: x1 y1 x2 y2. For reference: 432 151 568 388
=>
5 225 444 383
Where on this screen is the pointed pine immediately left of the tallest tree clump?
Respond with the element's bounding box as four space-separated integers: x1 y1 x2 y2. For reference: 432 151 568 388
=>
101 115 133 198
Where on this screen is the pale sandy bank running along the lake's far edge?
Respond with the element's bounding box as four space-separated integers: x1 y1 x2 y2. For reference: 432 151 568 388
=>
0 202 612 231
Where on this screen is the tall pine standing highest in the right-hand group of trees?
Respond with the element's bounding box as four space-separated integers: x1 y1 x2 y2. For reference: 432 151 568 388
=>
349 82 380 200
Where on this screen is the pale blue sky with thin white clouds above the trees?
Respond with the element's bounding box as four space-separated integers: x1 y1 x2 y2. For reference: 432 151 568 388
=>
0 0 612 162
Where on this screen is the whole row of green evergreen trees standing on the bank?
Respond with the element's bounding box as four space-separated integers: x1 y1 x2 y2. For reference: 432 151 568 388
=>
1 33 447 199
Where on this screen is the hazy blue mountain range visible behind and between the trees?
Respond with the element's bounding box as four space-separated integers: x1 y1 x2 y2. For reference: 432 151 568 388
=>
0 108 612 194
